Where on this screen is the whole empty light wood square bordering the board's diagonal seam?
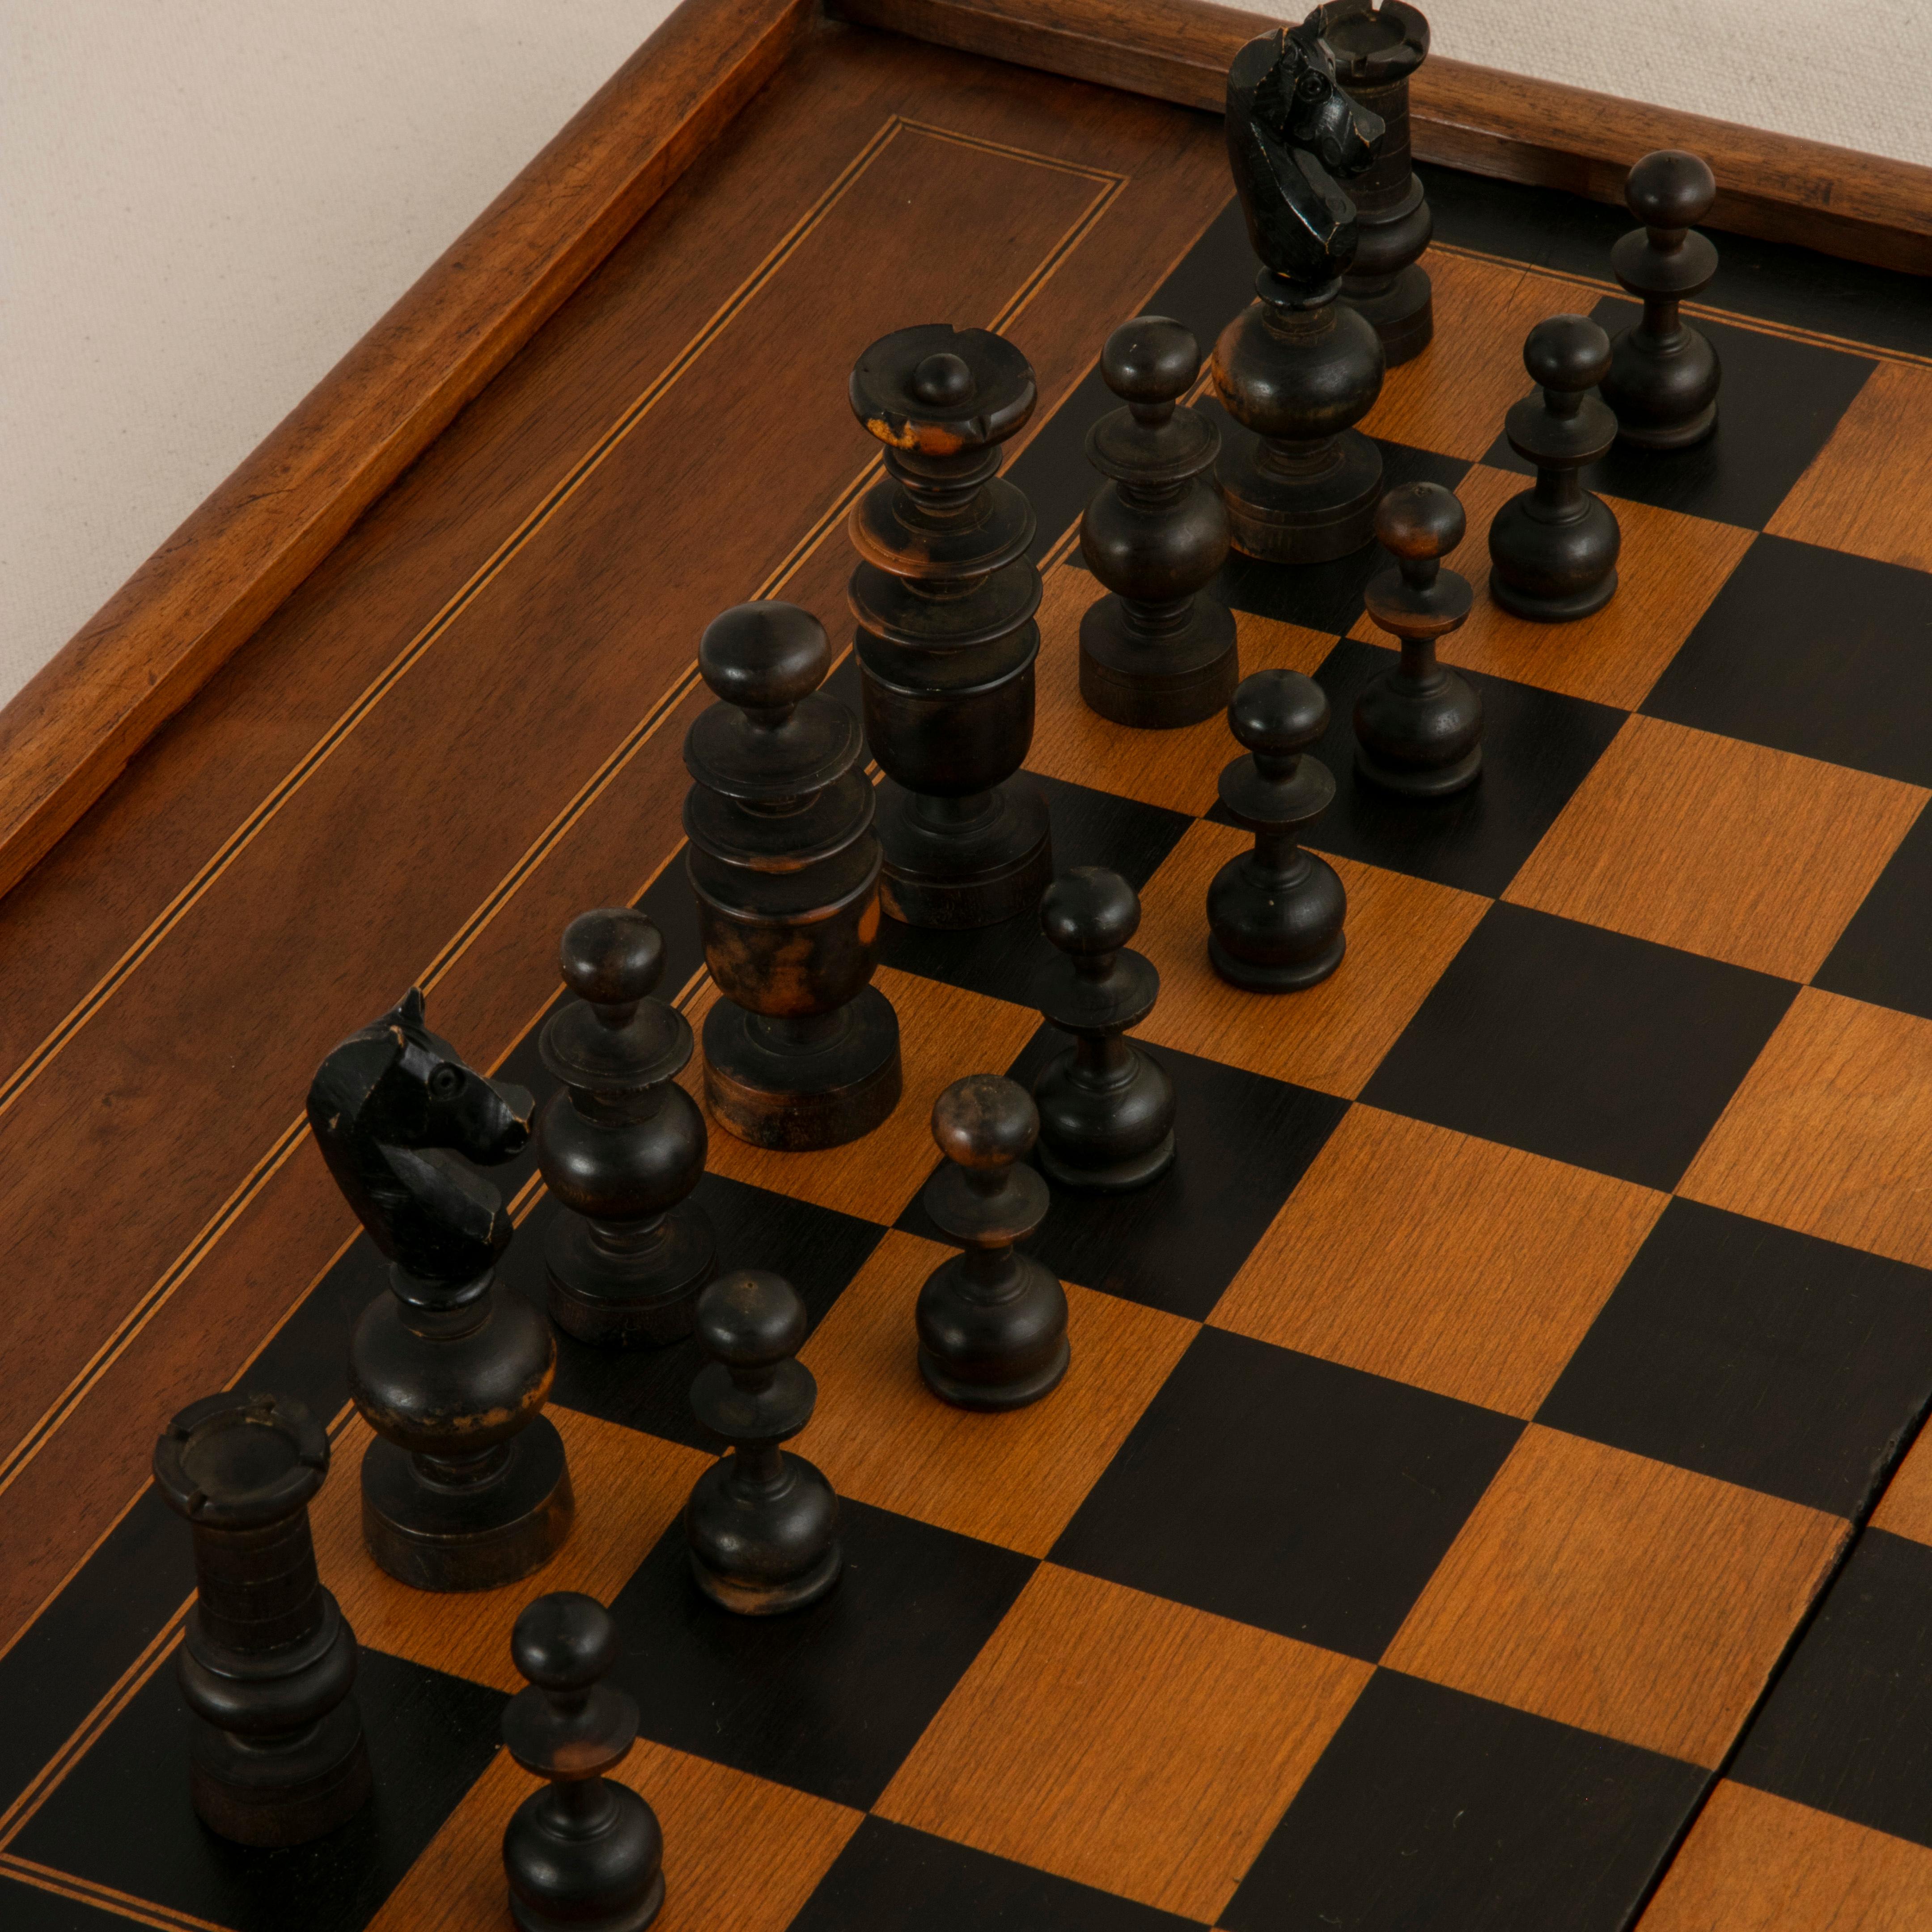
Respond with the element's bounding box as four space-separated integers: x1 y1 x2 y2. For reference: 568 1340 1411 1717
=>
1383 1422 1849 1766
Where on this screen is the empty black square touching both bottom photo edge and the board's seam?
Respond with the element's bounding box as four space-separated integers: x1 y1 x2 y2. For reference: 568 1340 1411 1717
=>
1221 1671 1708 1932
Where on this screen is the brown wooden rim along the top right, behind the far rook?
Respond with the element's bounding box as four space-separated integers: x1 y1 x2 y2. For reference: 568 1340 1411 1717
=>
833 0 1932 274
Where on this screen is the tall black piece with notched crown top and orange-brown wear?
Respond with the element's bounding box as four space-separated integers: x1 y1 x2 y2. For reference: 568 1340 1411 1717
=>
850 322 1053 928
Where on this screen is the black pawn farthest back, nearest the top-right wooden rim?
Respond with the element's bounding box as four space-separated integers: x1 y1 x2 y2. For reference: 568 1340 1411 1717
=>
1604 147 1723 450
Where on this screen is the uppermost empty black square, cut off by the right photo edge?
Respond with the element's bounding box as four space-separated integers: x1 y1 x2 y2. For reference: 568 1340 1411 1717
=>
1642 537 1932 784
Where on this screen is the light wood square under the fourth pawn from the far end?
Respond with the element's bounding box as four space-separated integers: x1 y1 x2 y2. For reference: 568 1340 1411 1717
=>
1134 819 1490 1099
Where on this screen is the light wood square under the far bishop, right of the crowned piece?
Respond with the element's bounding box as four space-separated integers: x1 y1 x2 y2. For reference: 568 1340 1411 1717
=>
1026 564 1335 813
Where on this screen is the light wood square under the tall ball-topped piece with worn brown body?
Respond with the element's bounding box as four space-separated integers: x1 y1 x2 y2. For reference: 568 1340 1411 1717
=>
678 966 1039 1223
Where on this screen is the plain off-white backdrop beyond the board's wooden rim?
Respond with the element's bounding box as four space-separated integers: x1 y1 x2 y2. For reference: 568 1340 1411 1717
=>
0 0 1932 699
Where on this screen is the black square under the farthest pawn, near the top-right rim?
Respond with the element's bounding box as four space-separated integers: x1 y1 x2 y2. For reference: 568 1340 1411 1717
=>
1484 307 1872 530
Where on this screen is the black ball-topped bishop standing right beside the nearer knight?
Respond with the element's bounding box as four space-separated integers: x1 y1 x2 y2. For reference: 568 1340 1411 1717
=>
537 906 717 1348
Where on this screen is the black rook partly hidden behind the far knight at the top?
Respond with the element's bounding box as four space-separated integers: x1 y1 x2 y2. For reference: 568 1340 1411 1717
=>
1306 0 1436 369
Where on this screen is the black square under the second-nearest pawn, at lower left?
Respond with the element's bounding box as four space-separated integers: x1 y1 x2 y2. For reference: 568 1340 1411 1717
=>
610 1497 1034 1809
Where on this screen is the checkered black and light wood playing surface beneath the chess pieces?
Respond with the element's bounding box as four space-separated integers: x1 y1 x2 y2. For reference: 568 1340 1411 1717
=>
11 154 1932 1932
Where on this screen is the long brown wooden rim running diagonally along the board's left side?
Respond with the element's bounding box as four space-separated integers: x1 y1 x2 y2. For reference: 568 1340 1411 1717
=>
0 0 811 893
